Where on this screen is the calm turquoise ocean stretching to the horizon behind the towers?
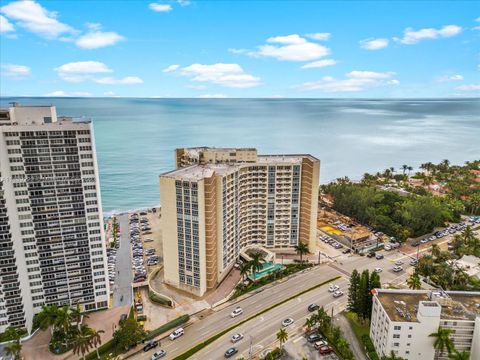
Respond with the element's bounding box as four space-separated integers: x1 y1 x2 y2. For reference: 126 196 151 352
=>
0 98 480 213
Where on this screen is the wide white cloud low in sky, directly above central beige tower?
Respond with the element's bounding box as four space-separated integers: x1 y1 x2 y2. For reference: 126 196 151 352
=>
171 63 260 88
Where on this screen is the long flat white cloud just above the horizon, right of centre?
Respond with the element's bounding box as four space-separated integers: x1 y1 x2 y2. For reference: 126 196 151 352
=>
297 70 400 93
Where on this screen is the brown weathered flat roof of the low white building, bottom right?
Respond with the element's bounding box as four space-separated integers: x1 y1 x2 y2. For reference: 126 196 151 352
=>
376 289 480 322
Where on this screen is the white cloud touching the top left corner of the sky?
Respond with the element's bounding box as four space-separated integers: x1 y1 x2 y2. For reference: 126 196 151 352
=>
0 1 75 38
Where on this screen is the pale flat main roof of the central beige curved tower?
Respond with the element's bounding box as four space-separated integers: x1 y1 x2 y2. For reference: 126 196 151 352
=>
160 154 317 181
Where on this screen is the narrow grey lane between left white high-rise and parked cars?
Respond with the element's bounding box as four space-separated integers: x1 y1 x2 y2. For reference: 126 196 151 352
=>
113 214 133 307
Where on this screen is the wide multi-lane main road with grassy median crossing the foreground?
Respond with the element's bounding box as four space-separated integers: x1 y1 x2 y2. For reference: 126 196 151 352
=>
133 251 420 359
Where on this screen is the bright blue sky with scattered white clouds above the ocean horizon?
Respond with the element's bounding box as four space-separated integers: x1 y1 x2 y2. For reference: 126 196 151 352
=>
0 0 480 98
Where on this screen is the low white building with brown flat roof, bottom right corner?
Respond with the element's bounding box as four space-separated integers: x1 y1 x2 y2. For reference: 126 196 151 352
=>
370 289 480 360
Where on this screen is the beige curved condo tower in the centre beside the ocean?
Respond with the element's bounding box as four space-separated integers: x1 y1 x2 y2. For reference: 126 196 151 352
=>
160 147 320 296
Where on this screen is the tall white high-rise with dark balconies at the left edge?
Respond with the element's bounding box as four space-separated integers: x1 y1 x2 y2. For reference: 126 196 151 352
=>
0 104 109 332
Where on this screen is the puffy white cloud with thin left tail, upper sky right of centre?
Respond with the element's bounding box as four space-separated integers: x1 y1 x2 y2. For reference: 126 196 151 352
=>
244 34 330 61
